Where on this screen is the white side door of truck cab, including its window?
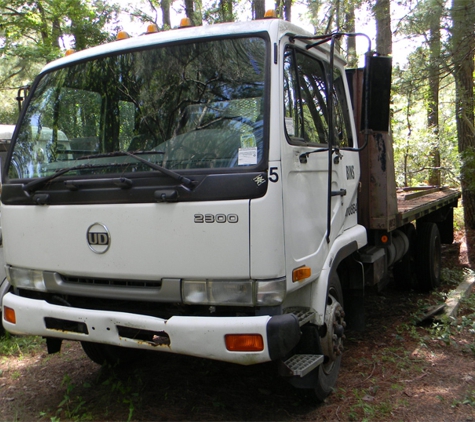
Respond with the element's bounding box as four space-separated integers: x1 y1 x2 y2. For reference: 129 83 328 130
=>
282 45 355 282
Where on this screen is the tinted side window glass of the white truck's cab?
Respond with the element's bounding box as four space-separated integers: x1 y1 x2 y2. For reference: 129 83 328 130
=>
284 47 352 146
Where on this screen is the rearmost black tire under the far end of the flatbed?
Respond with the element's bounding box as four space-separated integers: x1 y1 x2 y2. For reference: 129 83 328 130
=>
416 223 441 291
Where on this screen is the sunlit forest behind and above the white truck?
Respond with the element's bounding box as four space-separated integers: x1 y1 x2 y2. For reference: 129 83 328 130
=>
0 0 475 229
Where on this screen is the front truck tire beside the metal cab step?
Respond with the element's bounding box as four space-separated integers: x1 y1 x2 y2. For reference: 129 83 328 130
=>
314 273 346 402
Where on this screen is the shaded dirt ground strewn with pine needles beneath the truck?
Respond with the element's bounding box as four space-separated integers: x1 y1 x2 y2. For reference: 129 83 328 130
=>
0 233 475 421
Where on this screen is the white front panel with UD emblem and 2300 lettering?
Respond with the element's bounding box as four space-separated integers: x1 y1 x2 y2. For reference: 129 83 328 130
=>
2 200 250 280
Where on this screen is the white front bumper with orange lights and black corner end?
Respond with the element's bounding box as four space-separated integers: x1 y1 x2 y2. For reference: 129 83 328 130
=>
3 293 300 365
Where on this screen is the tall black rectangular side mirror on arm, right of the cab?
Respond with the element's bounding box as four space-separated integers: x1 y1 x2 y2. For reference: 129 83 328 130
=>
361 56 392 132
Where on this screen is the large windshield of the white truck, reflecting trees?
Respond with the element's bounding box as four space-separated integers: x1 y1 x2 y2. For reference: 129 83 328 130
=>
8 37 266 179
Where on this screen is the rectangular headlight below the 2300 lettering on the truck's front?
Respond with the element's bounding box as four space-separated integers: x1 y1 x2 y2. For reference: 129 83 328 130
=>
182 278 285 306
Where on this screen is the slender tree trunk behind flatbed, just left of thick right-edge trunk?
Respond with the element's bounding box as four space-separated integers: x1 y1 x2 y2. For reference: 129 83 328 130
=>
427 0 443 186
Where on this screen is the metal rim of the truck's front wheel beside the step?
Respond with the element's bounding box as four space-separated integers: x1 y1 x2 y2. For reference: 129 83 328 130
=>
322 294 346 375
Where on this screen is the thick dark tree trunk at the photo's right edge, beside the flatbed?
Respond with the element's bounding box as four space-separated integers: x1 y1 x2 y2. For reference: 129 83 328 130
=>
451 0 475 229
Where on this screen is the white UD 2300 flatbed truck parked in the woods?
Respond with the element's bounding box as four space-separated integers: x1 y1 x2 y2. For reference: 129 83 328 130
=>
1 19 460 400
